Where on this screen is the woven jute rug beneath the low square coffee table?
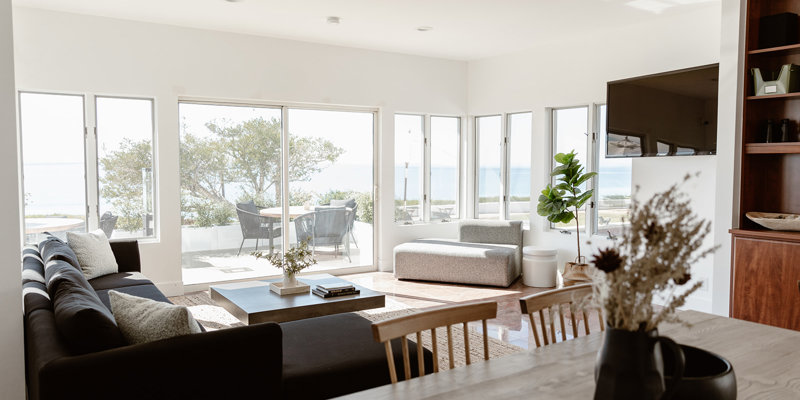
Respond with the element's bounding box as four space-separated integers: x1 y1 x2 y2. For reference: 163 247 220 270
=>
169 292 524 370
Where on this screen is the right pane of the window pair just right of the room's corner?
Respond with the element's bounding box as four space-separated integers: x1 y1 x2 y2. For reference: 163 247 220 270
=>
508 113 533 224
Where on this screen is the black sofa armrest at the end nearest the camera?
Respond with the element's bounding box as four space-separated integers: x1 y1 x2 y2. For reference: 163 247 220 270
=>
39 323 283 400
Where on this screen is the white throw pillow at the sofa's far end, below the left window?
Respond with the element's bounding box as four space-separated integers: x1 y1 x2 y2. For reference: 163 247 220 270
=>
67 229 119 280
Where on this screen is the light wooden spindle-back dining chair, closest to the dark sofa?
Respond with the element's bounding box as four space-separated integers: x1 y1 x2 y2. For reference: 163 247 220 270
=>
372 301 497 383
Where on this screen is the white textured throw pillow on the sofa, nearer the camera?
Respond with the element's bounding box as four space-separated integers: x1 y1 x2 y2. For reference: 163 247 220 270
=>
108 290 200 344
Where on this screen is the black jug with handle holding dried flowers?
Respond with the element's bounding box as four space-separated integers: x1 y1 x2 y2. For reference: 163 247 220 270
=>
594 327 684 400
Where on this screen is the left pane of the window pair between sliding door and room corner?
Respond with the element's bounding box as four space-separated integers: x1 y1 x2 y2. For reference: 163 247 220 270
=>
394 114 425 224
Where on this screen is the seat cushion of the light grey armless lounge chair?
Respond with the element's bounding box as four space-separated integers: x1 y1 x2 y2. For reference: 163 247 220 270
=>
394 239 520 287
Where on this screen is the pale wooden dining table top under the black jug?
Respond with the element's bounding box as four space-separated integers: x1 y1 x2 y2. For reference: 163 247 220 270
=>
342 311 800 400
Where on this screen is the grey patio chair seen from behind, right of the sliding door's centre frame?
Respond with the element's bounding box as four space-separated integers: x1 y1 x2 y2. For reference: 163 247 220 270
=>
294 206 353 261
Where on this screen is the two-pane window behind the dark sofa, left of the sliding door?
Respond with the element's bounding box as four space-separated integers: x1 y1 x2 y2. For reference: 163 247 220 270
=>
19 92 155 243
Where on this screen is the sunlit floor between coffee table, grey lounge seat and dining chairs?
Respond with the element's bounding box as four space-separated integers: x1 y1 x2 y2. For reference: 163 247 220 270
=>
340 272 599 348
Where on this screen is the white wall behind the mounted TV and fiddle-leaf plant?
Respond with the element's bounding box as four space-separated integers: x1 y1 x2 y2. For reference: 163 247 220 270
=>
469 4 734 311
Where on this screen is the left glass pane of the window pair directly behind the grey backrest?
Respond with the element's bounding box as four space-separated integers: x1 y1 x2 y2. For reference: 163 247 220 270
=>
475 115 503 219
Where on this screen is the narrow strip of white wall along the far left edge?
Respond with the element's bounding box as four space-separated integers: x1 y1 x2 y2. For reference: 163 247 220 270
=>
0 0 25 399
